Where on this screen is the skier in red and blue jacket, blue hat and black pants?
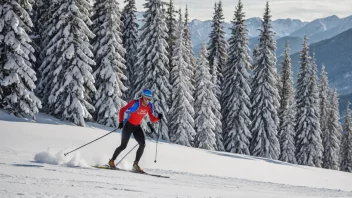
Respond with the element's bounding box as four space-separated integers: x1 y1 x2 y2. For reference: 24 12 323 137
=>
109 89 163 173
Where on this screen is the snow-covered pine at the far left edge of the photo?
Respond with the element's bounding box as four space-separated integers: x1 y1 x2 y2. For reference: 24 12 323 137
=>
0 0 41 118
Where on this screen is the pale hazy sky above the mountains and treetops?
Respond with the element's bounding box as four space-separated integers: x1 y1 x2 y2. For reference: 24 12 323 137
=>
130 0 352 21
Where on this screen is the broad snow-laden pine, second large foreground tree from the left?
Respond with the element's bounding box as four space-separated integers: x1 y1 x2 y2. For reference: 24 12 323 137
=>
44 0 96 126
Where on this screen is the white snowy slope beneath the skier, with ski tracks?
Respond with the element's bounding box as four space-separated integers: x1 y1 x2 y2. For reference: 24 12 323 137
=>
0 111 352 198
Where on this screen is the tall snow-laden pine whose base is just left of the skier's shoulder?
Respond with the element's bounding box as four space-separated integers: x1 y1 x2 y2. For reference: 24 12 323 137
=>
92 0 127 127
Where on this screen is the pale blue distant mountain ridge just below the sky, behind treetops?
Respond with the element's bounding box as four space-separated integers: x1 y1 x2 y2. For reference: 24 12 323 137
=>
189 15 352 56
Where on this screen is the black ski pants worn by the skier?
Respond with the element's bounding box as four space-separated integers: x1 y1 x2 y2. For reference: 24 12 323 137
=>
111 122 145 162
